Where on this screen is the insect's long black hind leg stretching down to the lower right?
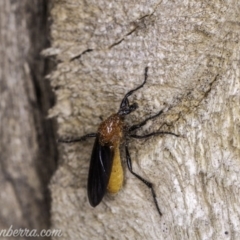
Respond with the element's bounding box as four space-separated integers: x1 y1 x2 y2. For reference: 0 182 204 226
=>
125 146 162 216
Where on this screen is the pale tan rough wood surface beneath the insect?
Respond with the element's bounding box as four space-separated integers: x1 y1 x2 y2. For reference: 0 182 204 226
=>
48 0 240 240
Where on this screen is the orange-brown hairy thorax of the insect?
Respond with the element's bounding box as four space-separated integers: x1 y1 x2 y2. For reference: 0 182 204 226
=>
98 113 124 147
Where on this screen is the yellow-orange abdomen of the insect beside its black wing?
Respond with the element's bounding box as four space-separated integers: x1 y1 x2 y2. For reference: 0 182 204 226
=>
107 145 123 193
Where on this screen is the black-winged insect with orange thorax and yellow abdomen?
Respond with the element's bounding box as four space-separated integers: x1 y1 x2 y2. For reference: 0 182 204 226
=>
59 67 179 216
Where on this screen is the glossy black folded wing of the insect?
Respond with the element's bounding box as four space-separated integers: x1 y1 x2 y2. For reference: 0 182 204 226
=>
88 136 113 207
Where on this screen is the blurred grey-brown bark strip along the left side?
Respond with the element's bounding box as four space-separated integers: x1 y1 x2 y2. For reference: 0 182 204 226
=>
0 0 57 239
